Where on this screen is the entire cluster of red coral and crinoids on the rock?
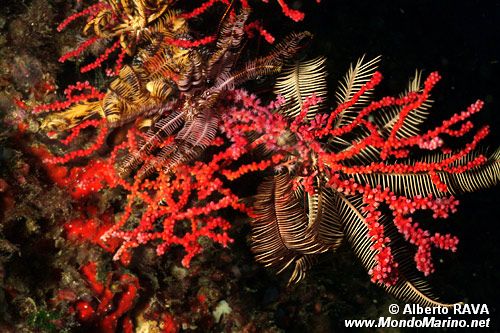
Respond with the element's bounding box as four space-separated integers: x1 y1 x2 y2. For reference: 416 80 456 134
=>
10 0 500 332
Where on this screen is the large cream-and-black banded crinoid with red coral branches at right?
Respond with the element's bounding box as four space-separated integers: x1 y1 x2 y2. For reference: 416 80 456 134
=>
248 58 500 306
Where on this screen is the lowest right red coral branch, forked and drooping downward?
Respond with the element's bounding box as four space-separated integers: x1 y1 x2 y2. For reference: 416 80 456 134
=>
331 177 458 286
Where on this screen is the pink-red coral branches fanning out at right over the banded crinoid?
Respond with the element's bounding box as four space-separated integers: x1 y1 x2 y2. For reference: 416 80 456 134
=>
216 73 488 286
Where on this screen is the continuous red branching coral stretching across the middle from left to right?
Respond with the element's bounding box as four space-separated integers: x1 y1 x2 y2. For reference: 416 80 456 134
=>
38 68 488 285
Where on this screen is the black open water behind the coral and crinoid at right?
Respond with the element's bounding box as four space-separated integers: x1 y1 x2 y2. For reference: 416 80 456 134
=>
260 0 500 326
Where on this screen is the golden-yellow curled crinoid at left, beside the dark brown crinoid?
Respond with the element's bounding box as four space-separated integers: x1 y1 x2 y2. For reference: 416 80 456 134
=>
41 34 193 132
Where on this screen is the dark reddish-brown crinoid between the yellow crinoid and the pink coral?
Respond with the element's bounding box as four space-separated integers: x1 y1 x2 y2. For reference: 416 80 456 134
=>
120 11 310 178
